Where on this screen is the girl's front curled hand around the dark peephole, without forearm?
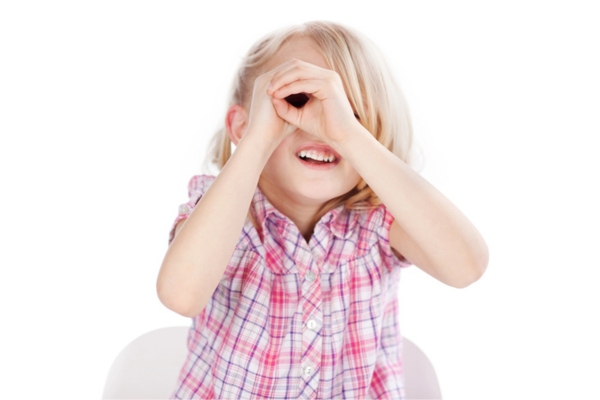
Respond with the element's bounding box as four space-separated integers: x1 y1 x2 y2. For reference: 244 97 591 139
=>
267 59 360 144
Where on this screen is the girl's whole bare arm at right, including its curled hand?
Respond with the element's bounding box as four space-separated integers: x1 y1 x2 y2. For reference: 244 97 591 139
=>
268 60 488 287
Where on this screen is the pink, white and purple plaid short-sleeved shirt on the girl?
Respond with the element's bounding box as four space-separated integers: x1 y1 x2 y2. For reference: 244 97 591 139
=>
171 175 408 399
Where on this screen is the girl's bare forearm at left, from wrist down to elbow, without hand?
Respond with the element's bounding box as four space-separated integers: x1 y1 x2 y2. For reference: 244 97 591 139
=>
157 135 275 317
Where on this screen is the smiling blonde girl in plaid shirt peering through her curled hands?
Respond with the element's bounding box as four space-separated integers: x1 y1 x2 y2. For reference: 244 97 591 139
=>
157 22 488 399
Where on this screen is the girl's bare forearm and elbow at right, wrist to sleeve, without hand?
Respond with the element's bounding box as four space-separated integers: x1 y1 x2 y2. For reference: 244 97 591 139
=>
334 127 488 287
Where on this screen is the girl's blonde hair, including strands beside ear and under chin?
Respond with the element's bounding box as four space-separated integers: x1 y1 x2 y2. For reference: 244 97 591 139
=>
209 21 412 218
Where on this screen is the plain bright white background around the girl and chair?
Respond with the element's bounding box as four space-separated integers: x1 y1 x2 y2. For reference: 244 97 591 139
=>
0 0 600 400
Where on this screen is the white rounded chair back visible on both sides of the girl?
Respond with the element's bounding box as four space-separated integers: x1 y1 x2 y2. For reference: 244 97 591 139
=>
102 326 441 399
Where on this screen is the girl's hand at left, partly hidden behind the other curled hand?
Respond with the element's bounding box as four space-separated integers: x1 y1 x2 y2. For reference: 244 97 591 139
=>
246 68 296 144
